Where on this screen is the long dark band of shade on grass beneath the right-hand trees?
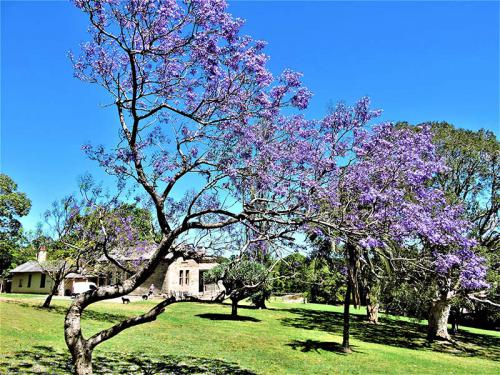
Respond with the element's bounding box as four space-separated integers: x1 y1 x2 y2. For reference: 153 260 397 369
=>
282 308 500 361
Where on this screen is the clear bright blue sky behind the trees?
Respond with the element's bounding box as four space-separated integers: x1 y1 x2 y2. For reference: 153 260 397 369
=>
0 1 500 232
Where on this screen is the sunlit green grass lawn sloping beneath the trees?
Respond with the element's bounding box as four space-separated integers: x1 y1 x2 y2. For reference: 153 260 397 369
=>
0 295 500 375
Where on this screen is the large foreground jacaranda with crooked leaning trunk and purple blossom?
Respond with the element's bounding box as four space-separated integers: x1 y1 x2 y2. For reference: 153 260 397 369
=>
65 0 311 374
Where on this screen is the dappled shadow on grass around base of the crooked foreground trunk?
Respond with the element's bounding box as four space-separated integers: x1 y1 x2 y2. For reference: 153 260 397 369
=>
0 346 255 375
